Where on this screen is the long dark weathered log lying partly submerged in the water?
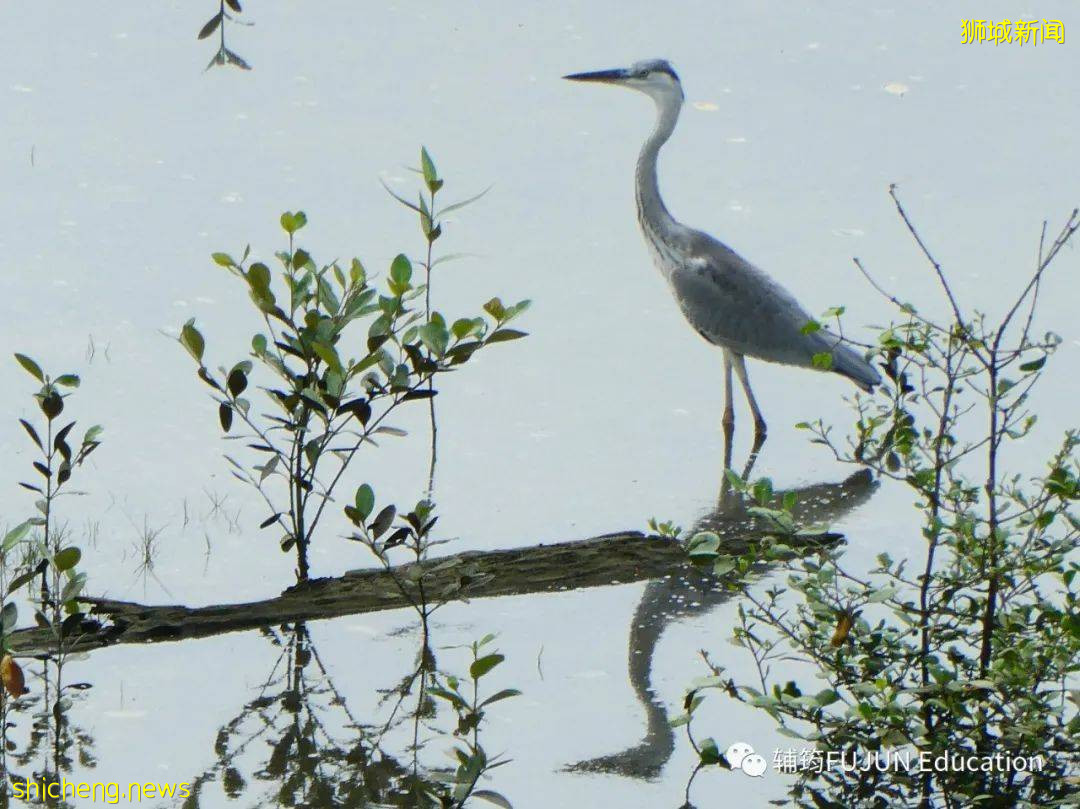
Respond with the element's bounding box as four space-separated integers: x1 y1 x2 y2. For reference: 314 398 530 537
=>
8 526 839 656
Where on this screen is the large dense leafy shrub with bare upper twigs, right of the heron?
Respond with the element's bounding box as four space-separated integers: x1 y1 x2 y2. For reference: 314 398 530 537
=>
683 197 1080 809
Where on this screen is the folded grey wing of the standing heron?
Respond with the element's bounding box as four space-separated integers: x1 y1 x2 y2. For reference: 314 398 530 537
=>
669 234 828 366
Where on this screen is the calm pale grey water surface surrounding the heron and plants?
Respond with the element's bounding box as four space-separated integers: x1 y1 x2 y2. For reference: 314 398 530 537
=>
0 0 1080 809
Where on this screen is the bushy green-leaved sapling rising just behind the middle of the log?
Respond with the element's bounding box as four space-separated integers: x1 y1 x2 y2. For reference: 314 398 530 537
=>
179 212 528 581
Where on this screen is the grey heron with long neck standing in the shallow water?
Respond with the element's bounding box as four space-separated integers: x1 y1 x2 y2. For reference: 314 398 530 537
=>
563 59 881 447
